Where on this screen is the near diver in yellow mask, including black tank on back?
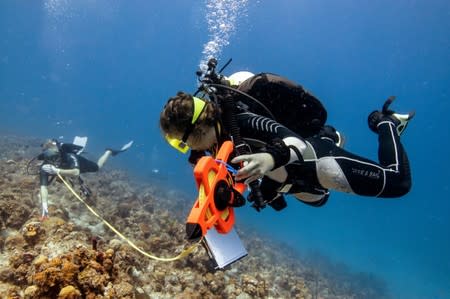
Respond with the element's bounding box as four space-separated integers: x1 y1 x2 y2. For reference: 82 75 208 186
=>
160 68 414 211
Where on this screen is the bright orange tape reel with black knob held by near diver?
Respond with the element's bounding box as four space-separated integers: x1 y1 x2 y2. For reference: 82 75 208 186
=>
186 141 246 239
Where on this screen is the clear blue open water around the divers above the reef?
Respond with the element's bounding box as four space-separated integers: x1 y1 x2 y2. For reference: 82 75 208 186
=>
0 0 450 299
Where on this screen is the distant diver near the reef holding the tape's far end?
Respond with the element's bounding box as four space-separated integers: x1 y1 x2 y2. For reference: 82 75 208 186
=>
37 139 133 219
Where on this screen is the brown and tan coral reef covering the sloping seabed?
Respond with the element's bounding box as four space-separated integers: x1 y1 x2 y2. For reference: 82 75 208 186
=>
0 136 385 299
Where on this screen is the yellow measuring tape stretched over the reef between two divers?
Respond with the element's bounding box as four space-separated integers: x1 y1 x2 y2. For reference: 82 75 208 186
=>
58 173 203 262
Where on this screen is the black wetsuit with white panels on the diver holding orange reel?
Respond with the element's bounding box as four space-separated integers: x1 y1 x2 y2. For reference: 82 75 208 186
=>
238 112 411 206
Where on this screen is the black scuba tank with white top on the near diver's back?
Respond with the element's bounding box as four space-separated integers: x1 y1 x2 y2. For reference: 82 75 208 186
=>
189 71 345 168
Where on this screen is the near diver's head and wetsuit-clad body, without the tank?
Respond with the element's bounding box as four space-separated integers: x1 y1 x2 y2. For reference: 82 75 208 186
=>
160 72 414 210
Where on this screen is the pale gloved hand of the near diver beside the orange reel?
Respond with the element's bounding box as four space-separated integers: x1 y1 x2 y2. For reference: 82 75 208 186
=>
231 153 275 184
